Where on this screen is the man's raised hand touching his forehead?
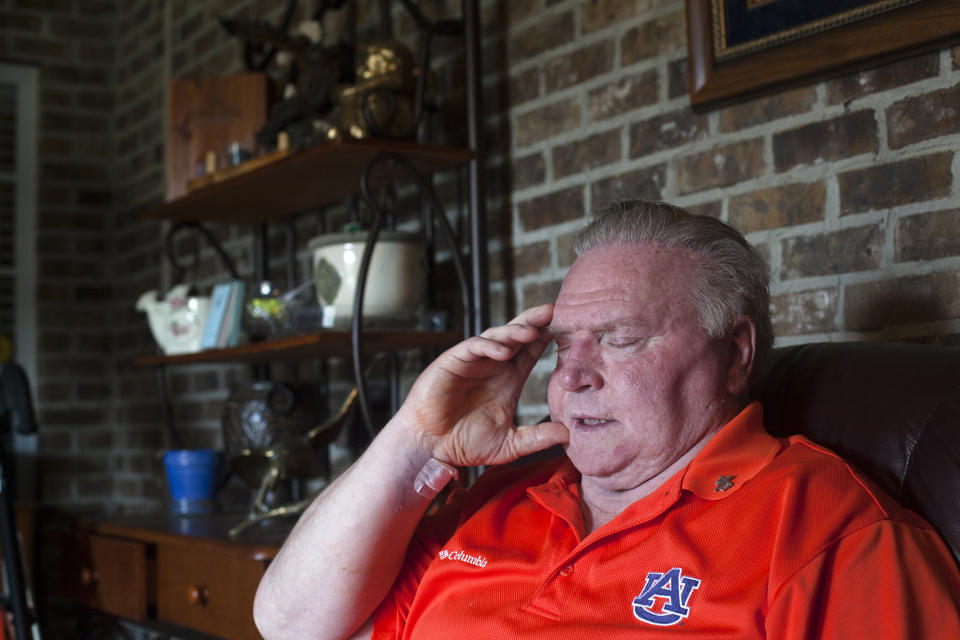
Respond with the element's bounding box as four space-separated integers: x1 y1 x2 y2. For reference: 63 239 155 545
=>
395 304 568 466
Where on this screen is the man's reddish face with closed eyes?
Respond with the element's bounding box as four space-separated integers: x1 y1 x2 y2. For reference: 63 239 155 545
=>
548 245 737 489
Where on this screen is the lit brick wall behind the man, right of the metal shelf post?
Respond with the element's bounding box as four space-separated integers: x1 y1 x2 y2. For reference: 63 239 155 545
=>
484 0 960 419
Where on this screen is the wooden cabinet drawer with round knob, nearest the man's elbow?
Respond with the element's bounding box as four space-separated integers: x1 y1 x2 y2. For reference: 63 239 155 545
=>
157 544 264 640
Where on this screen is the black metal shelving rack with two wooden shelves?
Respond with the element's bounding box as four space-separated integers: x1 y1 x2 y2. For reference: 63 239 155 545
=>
134 0 489 430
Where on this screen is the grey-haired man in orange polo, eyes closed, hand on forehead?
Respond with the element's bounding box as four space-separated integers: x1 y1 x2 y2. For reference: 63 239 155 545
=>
254 202 960 640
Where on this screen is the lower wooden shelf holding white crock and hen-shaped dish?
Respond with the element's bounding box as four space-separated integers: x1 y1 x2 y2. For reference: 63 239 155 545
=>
133 329 463 367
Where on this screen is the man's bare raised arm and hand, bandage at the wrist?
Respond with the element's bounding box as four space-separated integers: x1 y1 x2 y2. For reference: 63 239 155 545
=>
254 305 567 640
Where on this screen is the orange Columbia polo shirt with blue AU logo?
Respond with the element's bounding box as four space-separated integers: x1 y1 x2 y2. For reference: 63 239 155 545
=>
373 403 960 640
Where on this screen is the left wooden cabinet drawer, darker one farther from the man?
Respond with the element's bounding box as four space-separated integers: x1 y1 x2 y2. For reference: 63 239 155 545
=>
60 533 150 620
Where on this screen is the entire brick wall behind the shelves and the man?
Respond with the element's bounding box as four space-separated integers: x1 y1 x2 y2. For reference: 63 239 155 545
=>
0 0 960 510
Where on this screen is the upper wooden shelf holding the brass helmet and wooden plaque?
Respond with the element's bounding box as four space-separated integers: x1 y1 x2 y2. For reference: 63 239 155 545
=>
141 138 473 223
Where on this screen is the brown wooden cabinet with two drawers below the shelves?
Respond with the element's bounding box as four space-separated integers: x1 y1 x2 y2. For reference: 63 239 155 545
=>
47 515 286 640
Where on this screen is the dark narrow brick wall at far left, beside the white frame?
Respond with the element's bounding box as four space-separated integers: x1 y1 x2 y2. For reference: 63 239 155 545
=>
0 0 116 505
